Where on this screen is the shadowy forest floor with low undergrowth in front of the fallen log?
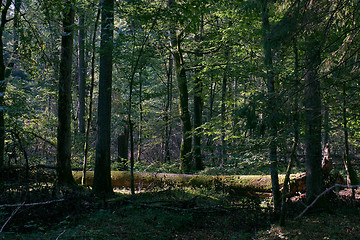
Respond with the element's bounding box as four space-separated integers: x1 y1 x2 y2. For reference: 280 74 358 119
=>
0 184 360 240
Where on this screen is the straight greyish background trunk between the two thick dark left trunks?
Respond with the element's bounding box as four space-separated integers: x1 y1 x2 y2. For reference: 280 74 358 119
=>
78 9 86 134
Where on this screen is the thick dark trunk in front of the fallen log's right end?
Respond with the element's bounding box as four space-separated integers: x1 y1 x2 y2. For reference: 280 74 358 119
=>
304 35 323 202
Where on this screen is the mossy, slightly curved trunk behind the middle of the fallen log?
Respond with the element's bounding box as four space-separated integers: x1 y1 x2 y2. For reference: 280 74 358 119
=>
168 0 192 173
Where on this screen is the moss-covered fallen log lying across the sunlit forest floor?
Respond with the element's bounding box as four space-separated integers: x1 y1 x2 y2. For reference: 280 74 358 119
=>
73 171 299 193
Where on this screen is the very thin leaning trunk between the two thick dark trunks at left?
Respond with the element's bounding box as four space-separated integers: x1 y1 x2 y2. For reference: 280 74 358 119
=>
81 8 101 185
